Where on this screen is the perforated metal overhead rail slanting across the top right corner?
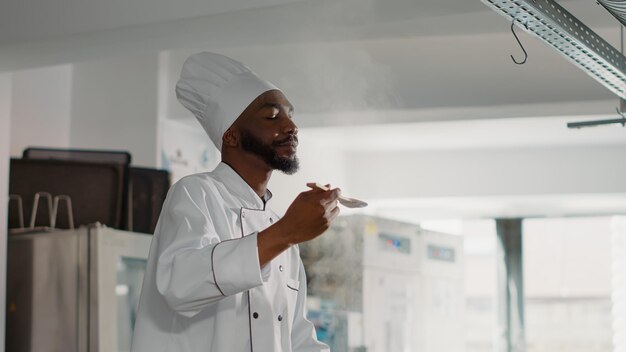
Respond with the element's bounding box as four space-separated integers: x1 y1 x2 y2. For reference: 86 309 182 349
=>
481 0 626 99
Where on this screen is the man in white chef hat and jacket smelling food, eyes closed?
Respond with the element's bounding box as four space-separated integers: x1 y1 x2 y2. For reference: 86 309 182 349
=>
132 52 340 352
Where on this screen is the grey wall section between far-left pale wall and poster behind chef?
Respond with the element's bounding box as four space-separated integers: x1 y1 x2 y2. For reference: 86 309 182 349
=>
70 53 158 167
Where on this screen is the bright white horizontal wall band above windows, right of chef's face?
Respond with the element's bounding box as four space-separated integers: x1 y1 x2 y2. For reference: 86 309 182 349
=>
347 145 626 199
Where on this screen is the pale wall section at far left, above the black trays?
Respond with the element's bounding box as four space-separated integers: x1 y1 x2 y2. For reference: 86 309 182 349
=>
11 65 72 157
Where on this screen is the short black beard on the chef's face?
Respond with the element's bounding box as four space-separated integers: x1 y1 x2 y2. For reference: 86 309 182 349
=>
240 129 300 175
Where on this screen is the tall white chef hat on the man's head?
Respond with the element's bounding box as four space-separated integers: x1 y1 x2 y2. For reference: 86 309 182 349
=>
176 52 278 151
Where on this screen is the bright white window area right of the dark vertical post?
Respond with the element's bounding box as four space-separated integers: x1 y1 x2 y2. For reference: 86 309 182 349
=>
522 217 612 298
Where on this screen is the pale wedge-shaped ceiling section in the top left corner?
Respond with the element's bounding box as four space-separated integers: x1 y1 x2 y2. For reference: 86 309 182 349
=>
0 0 308 45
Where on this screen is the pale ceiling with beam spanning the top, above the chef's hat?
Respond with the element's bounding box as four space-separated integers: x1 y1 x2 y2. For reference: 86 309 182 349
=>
0 0 619 110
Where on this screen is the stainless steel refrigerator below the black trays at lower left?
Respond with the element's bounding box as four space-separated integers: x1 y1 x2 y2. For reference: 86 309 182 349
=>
6 224 152 352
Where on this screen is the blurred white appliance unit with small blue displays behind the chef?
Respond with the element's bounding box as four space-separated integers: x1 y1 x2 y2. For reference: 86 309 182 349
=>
300 215 464 352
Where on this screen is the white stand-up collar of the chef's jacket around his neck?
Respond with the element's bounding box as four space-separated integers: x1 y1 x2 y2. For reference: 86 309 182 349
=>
212 161 272 210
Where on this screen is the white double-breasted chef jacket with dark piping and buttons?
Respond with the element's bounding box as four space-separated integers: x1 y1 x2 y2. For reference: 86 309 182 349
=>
131 163 328 352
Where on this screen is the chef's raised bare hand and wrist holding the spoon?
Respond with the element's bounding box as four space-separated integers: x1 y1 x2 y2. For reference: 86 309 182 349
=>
257 183 341 266
